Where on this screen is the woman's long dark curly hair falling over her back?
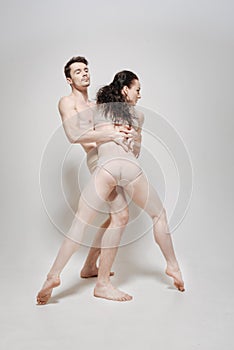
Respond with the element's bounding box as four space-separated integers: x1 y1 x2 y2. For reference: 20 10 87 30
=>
97 70 139 126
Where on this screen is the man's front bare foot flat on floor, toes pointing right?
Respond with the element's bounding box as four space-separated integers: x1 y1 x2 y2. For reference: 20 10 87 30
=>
94 283 132 301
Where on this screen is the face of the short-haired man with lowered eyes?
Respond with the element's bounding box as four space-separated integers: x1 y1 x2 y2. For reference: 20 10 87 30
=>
67 62 90 90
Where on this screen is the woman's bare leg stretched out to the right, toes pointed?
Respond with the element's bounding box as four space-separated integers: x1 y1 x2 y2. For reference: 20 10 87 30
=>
125 174 184 291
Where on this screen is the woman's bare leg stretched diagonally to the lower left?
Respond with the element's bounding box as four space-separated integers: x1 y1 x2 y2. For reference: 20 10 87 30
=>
37 169 116 304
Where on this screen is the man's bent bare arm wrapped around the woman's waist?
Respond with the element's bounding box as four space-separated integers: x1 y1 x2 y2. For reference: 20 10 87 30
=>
58 97 129 144
